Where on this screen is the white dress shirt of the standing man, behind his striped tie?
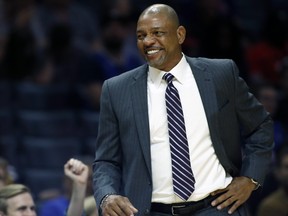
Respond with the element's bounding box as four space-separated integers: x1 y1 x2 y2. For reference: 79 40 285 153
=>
147 55 232 203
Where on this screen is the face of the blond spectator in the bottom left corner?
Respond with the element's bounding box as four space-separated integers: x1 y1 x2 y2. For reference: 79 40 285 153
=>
7 193 37 216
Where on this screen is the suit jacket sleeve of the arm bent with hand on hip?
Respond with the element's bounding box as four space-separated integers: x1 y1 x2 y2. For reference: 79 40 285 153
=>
231 61 274 185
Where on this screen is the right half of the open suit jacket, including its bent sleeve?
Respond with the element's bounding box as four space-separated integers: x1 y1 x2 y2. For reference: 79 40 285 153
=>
188 58 274 185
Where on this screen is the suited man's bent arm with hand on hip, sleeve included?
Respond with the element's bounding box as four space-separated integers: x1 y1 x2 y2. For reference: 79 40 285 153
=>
212 61 273 214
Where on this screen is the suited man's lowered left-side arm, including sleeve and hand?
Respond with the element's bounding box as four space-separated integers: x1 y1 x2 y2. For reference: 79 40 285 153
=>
93 80 137 216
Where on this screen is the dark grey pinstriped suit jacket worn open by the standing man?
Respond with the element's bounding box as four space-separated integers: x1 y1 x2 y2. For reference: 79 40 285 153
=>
93 57 273 215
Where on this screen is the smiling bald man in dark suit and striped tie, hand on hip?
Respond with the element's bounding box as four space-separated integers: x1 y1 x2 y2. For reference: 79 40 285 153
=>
93 4 273 216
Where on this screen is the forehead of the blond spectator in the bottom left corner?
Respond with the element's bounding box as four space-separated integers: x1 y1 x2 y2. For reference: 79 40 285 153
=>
7 193 35 211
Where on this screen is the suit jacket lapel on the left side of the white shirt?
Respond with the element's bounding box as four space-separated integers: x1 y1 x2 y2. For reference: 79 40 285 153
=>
131 65 151 179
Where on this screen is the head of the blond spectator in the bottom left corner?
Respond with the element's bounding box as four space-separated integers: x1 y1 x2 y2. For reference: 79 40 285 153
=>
0 184 37 216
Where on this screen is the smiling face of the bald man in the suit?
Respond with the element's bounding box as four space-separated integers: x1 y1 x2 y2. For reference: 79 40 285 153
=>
137 13 186 71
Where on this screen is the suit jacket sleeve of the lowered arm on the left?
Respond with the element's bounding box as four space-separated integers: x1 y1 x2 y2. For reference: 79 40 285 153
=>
93 81 122 209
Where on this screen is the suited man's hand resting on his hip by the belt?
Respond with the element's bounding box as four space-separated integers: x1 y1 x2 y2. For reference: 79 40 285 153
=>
211 176 255 214
